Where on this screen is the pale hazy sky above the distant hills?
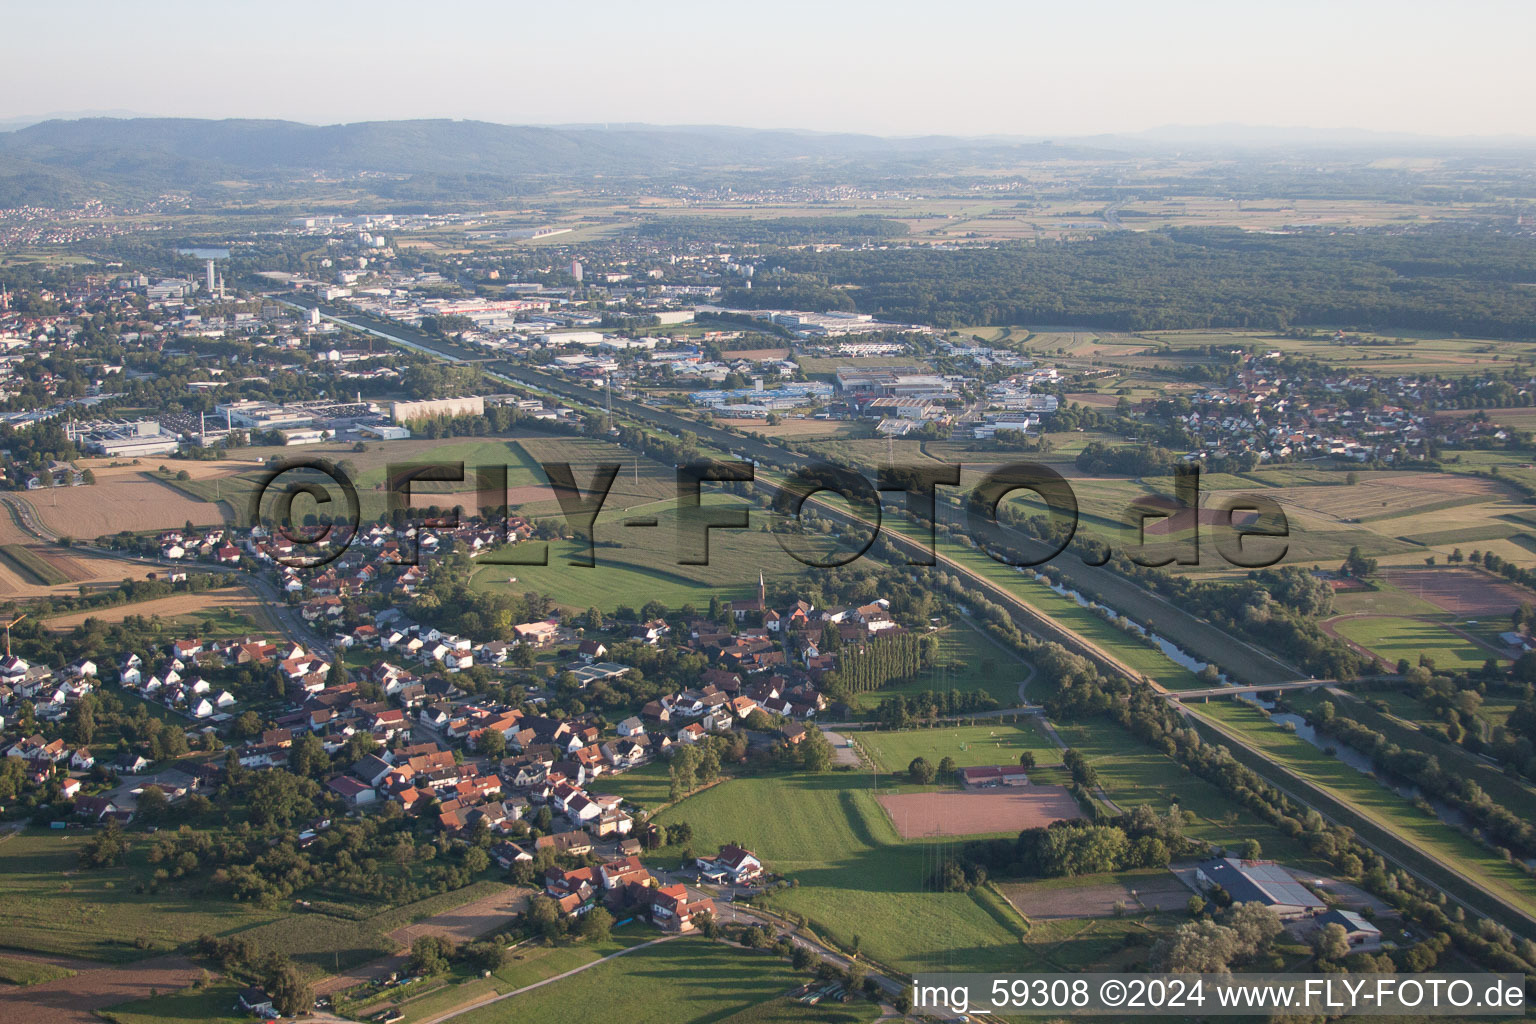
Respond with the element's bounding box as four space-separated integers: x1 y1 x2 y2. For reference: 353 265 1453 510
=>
12 0 1536 135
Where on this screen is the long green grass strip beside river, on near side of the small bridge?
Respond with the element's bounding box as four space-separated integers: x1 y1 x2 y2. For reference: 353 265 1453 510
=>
1192 700 1536 913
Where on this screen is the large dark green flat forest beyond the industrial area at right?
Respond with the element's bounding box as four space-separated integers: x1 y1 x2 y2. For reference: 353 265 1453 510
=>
725 227 1536 338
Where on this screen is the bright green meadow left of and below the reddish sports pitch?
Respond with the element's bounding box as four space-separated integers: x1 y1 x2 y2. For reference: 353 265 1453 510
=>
653 772 1020 972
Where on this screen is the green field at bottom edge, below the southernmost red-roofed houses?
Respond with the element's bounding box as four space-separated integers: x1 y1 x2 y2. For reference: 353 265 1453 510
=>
456 936 877 1024
